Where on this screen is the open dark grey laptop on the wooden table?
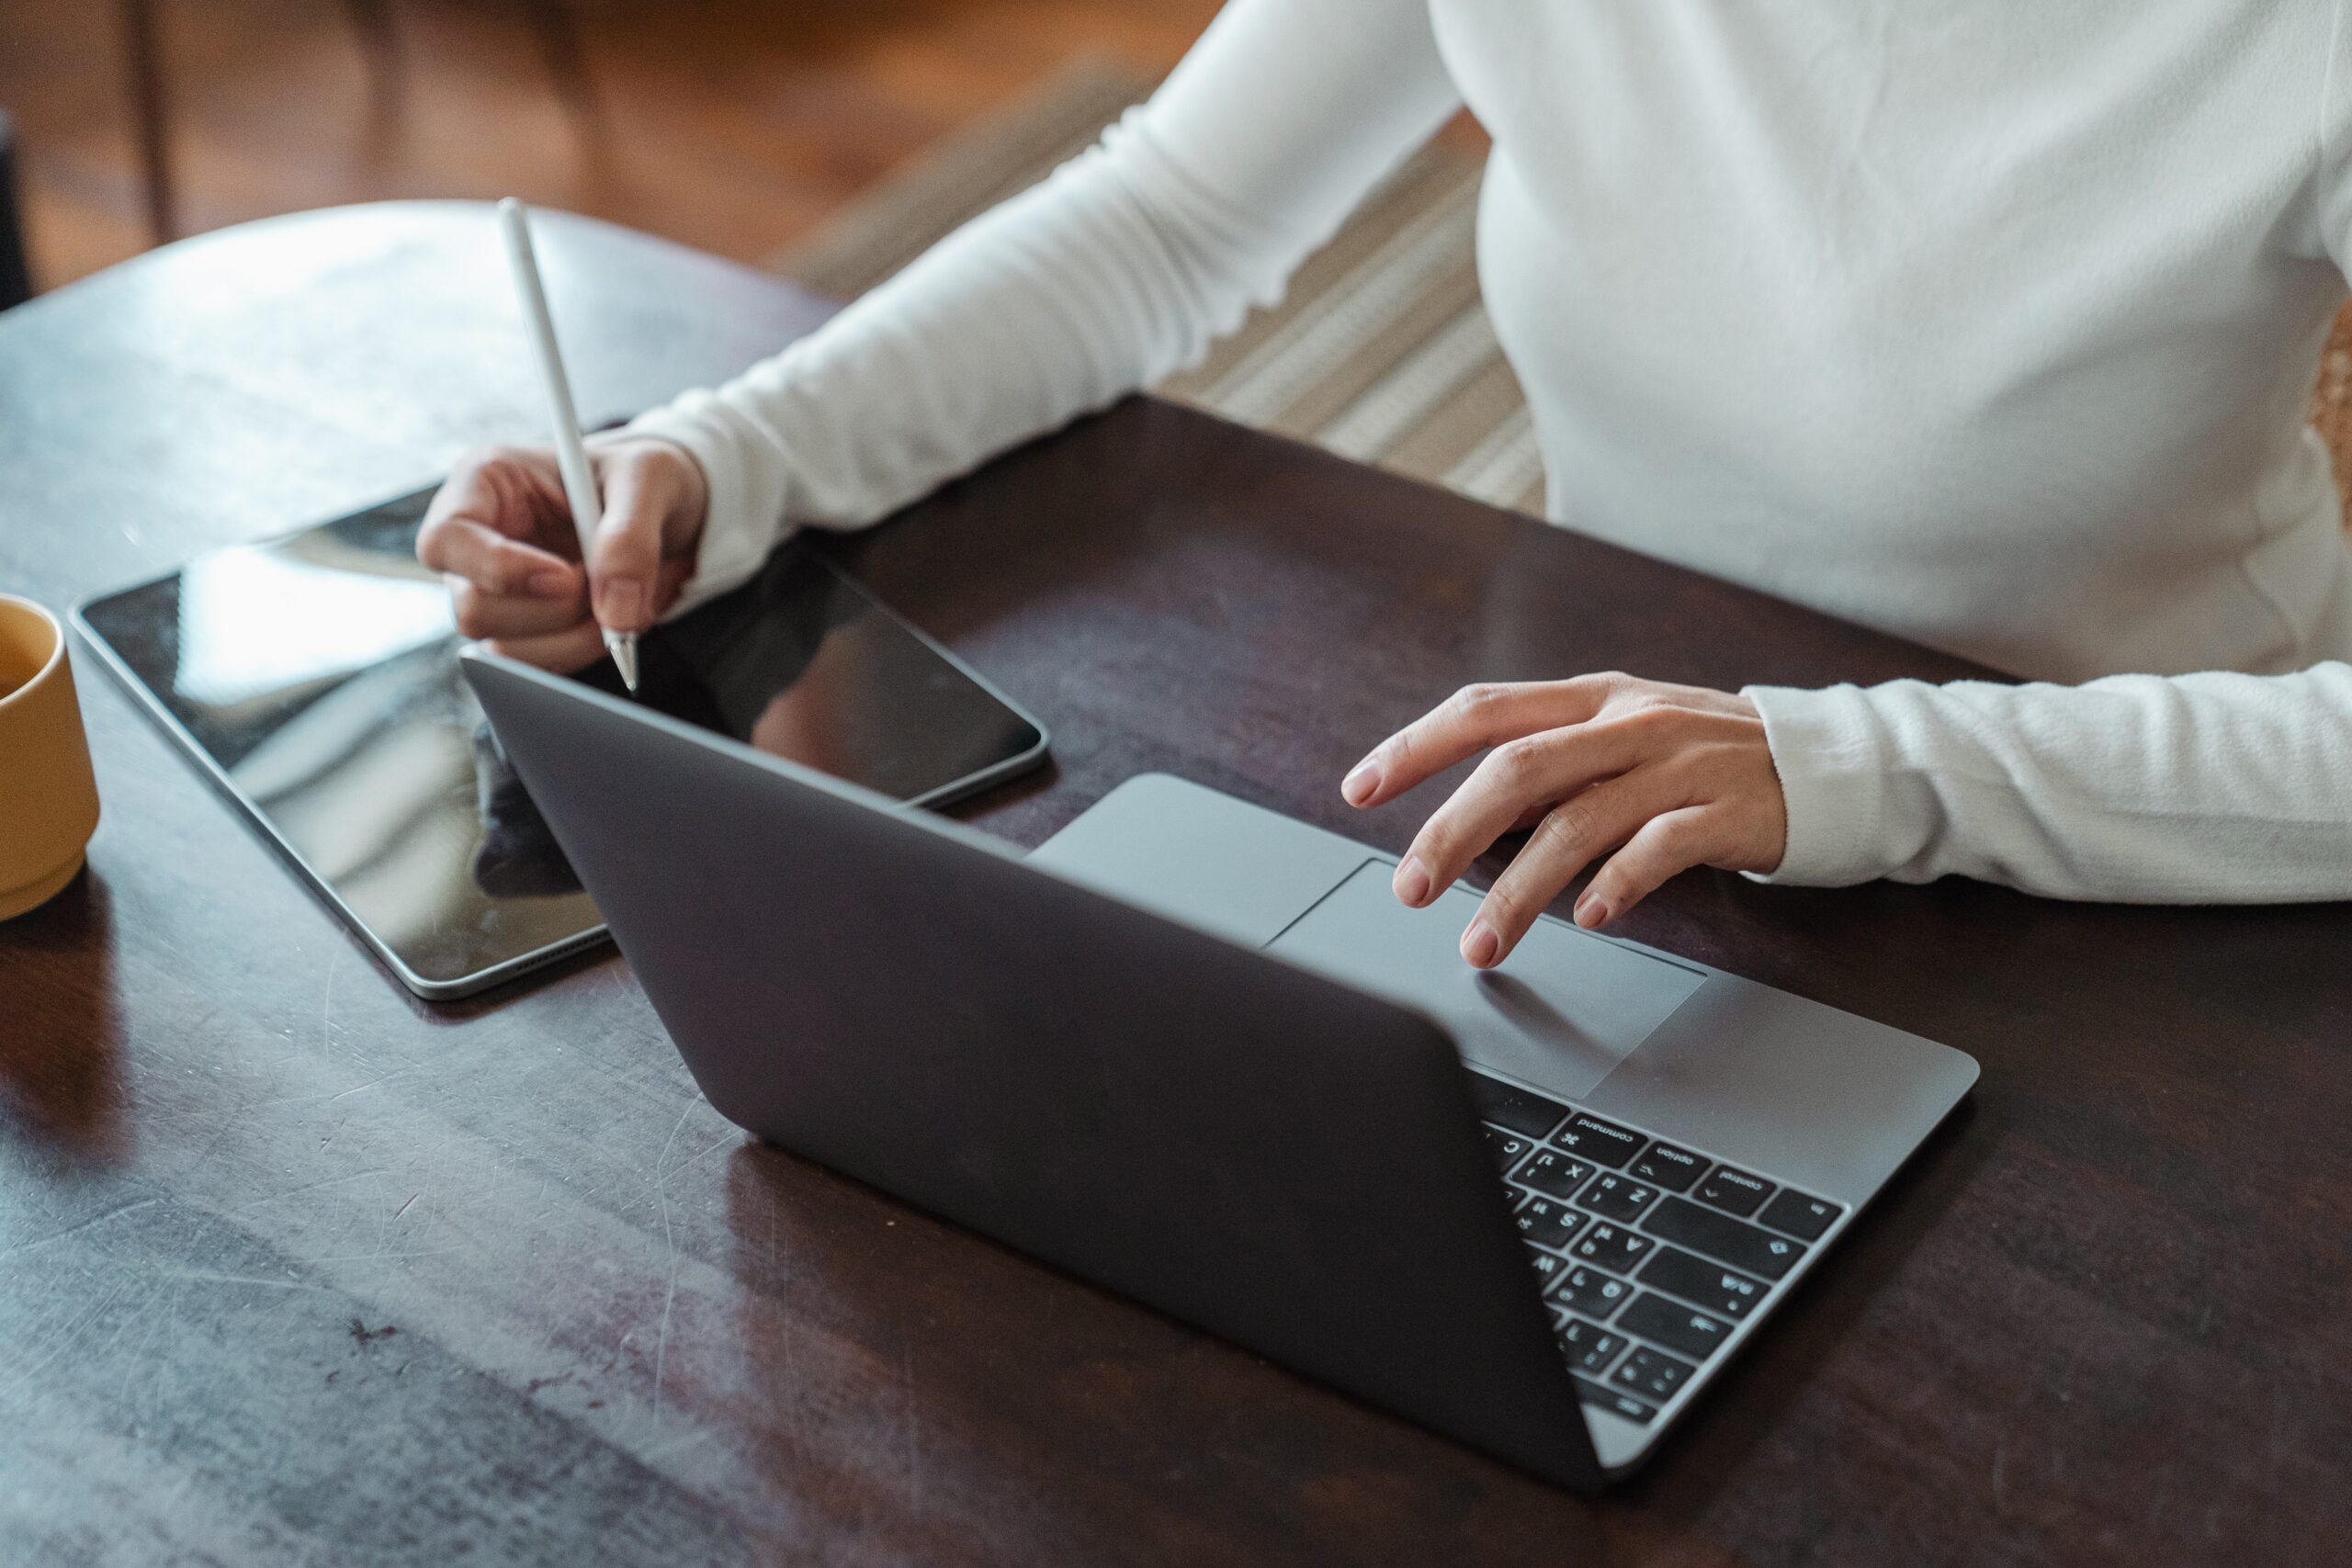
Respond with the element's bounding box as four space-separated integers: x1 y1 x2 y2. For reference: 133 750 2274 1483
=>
466 653 1978 1488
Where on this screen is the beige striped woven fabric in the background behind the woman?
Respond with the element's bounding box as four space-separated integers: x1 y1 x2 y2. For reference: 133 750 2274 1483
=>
772 62 2352 525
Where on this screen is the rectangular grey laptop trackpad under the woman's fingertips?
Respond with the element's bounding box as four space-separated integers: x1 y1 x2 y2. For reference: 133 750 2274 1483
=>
1265 861 1705 1100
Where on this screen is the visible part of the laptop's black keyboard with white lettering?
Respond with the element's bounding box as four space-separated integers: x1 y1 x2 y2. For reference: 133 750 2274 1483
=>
1470 1072 1847 1425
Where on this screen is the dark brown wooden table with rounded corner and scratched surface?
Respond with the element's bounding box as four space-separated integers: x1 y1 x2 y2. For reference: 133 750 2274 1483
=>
0 205 2352 1565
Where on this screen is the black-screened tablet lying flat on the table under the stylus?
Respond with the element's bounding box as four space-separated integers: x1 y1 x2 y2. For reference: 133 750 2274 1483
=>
73 489 1046 997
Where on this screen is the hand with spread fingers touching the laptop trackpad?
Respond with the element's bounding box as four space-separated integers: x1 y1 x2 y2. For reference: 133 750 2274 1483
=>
1340 674 1788 968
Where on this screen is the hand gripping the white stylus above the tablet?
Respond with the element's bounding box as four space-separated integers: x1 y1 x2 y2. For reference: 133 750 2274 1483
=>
416 434 710 670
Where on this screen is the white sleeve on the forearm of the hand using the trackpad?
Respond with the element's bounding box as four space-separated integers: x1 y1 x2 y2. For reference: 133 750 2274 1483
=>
1746 663 2352 903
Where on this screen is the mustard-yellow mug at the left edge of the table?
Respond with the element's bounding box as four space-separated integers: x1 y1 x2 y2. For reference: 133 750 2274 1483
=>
0 592 99 919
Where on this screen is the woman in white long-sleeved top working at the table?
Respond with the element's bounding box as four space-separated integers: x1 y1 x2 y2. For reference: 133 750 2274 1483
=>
419 0 2352 964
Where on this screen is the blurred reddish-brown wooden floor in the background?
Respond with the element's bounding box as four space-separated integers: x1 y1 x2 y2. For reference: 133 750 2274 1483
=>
0 0 1216 289
